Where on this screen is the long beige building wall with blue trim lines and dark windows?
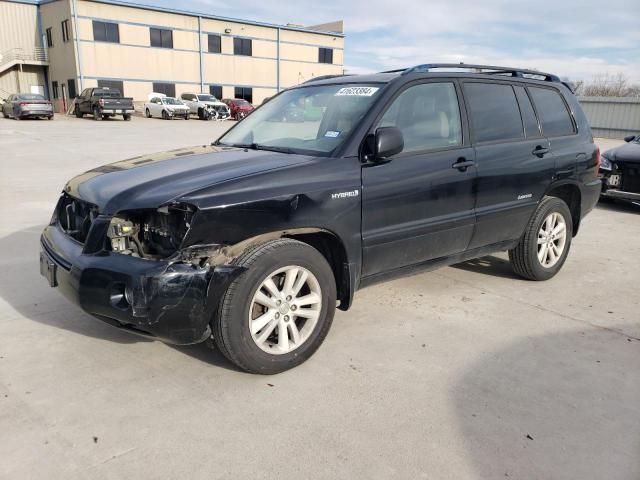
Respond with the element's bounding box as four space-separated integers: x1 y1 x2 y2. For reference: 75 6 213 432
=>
67 0 344 104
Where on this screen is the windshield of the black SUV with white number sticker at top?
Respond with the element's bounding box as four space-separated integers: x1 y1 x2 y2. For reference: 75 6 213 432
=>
218 84 382 155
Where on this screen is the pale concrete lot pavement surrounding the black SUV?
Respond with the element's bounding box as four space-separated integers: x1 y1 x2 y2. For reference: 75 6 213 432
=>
0 117 640 480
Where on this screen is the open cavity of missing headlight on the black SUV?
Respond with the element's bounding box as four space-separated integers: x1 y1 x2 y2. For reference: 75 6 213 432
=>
107 204 195 259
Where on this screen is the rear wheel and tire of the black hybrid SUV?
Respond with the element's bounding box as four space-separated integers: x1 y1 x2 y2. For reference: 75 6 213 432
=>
509 197 573 280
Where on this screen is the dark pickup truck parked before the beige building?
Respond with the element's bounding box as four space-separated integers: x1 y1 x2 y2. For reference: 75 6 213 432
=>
73 87 133 120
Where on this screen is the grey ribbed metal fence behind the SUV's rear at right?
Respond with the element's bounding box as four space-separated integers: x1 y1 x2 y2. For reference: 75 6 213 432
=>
578 97 640 139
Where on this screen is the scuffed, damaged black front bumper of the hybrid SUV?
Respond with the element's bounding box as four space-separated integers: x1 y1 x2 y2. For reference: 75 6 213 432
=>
40 224 242 345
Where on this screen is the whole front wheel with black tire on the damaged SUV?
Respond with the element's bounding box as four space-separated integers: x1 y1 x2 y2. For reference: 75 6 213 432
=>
212 239 336 374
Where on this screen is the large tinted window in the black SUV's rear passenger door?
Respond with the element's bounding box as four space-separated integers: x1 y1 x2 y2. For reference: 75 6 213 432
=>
464 82 524 142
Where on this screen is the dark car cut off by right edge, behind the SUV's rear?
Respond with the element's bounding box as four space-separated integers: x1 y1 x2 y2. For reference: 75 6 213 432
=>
600 134 640 205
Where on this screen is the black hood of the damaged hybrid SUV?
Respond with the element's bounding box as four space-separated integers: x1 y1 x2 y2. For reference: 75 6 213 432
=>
64 145 313 215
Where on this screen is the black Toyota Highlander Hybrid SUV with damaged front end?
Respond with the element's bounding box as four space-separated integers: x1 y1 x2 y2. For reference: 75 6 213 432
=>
41 64 601 373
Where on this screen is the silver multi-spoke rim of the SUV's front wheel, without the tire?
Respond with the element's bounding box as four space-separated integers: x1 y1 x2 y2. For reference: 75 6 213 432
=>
249 265 322 355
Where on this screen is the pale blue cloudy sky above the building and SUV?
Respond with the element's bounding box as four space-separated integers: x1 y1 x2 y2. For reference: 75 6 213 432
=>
151 0 640 83
